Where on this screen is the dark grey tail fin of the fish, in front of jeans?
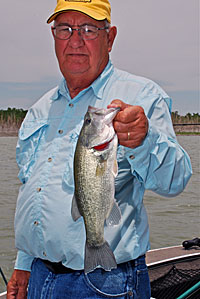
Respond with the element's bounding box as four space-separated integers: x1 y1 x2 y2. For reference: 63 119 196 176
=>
84 241 117 273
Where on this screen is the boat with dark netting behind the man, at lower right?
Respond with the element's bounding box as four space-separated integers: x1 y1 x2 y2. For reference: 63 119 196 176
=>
0 238 200 299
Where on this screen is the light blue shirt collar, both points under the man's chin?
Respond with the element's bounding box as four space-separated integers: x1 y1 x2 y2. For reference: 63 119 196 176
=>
51 60 114 101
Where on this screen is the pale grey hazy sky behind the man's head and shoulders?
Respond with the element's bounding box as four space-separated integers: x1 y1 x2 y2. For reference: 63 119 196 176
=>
0 0 200 115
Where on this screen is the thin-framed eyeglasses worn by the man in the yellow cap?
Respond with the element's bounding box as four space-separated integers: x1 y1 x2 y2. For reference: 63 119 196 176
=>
52 25 109 40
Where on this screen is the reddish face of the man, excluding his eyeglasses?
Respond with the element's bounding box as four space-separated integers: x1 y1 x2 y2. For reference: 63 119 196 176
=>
54 11 116 82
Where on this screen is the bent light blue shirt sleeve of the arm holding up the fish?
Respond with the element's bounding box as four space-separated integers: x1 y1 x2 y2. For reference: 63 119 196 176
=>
126 85 192 197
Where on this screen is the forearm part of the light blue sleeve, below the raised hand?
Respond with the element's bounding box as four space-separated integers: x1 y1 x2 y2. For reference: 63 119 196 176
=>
126 120 192 196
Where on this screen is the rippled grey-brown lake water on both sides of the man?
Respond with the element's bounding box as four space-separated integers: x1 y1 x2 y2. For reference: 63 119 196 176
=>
0 136 200 292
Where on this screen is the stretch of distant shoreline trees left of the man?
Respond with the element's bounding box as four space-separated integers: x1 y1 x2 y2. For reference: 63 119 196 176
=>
0 108 27 128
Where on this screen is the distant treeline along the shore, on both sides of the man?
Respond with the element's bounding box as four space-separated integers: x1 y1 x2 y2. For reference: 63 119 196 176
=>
0 108 200 127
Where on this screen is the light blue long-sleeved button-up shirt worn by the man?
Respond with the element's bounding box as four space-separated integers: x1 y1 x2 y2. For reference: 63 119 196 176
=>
15 61 192 270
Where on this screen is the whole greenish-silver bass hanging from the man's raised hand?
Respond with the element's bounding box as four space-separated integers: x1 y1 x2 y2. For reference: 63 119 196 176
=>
71 106 121 274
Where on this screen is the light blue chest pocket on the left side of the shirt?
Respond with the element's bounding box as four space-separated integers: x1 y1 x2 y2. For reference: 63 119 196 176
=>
16 121 48 184
